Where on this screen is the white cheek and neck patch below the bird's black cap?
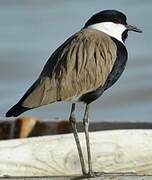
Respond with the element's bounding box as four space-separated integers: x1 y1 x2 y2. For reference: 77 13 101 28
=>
89 22 127 44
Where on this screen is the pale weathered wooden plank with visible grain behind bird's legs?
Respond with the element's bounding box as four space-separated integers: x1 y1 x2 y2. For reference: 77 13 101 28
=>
0 130 152 177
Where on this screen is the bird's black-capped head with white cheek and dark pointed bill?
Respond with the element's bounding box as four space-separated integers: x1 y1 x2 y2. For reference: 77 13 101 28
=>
84 10 142 43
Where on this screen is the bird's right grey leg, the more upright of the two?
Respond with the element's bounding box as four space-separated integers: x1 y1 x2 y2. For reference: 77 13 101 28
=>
83 104 93 176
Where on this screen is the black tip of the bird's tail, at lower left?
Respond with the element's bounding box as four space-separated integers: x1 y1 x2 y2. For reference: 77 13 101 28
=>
6 104 31 117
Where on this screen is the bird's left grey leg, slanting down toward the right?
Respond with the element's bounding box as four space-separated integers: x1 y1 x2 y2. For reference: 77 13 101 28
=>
69 103 87 175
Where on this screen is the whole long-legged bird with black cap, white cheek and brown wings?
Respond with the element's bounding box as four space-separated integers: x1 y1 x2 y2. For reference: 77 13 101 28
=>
6 9 142 177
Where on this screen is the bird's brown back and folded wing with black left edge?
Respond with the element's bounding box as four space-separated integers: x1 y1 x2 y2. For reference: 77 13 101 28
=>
22 29 117 108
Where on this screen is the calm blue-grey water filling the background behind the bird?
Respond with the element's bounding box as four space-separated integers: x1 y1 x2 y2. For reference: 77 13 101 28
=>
0 0 152 121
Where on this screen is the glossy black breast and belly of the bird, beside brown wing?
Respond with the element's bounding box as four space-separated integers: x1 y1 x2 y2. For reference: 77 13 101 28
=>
80 38 128 104
